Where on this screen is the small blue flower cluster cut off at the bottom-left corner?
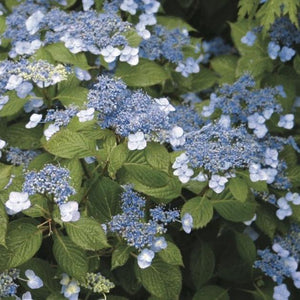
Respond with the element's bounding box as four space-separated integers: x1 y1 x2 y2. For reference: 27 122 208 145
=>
0 269 20 297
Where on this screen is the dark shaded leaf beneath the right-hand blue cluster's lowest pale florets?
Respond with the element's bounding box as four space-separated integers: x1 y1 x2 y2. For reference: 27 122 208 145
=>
211 200 256 222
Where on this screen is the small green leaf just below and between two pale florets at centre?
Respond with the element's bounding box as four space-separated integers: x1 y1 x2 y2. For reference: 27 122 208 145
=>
144 142 170 172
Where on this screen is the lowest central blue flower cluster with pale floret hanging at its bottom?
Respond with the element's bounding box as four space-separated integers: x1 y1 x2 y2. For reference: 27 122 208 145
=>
108 186 179 268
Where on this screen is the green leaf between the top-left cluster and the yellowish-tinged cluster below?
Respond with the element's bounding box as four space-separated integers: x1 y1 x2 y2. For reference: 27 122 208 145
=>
44 43 90 70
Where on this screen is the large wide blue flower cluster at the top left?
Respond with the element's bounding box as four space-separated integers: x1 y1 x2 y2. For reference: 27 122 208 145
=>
3 0 131 61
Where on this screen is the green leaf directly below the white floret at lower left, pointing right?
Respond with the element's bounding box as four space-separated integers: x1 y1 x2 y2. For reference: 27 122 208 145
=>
65 217 109 251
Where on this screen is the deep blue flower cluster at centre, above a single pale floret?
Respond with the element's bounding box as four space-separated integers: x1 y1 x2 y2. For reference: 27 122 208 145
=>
87 75 174 146
